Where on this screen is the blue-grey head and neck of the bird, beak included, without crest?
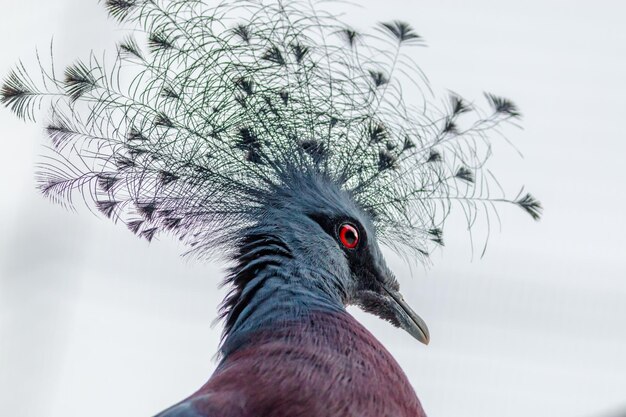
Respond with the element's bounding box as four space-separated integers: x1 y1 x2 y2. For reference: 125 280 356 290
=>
217 171 429 353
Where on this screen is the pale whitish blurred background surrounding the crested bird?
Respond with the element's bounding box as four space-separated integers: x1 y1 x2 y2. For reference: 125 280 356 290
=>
0 0 626 417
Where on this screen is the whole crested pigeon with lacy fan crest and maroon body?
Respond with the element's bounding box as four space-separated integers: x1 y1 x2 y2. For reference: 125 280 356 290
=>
0 0 543 417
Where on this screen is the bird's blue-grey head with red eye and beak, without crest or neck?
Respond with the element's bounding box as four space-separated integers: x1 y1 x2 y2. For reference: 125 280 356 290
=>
259 171 430 344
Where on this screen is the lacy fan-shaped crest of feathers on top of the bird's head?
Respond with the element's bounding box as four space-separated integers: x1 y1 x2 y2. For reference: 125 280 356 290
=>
0 0 542 255
